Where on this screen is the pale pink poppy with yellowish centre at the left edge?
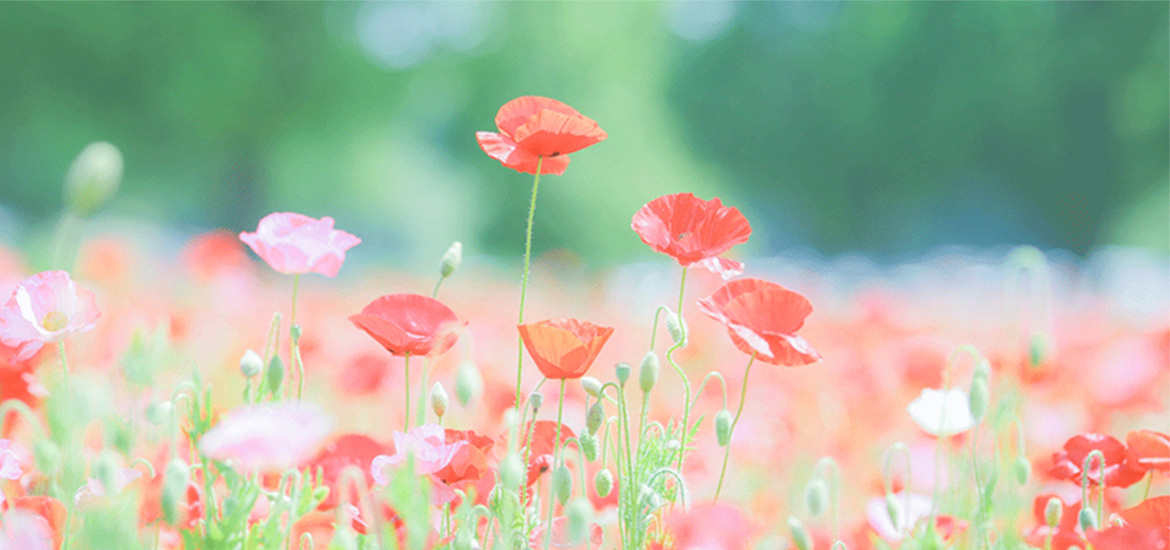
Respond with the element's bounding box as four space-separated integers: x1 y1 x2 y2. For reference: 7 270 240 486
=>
0 271 102 362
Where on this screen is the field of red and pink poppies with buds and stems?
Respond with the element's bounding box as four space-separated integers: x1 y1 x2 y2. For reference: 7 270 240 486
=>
0 96 1170 550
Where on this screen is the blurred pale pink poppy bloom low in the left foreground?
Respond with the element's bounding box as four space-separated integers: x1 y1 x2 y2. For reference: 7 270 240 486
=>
199 403 333 472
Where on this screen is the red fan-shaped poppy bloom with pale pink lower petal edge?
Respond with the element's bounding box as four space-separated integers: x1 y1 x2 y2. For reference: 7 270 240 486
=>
629 193 751 280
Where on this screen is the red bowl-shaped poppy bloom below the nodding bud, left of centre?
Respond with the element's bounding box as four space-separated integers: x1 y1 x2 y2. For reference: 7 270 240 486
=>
350 294 467 356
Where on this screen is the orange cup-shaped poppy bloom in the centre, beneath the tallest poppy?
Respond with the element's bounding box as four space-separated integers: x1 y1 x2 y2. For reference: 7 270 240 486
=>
516 318 613 380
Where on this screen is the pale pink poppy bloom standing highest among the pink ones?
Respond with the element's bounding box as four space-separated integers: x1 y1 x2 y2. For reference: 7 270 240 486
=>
240 212 362 277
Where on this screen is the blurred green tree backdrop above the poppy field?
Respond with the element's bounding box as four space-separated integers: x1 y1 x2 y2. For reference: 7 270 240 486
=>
0 2 1170 269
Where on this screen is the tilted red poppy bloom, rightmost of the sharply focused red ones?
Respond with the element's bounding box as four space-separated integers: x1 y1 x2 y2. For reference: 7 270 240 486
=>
698 279 820 366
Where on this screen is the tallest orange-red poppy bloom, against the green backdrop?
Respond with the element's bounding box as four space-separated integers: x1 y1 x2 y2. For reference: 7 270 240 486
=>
475 96 607 176
